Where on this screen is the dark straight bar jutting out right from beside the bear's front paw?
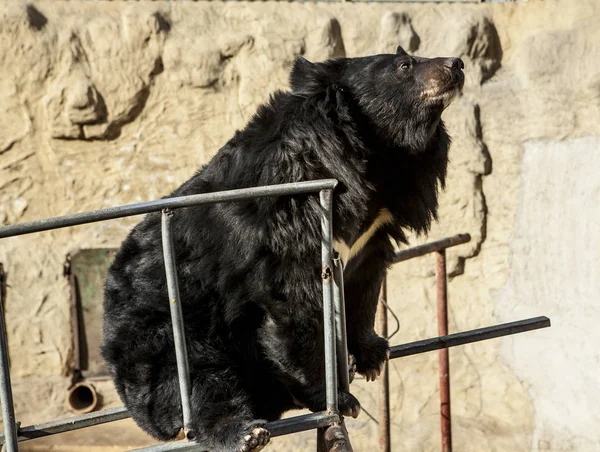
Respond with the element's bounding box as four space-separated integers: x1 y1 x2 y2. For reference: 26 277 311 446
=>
390 317 550 359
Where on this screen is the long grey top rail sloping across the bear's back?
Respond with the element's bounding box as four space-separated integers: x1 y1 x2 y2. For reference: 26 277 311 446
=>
0 179 337 238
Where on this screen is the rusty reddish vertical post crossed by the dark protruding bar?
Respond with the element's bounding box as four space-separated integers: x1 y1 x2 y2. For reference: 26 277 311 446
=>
435 249 452 452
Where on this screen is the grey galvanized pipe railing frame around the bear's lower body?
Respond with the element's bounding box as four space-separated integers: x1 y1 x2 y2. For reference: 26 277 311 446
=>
0 179 348 452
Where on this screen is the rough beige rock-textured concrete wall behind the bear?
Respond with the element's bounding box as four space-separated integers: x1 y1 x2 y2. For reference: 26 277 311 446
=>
0 0 600 452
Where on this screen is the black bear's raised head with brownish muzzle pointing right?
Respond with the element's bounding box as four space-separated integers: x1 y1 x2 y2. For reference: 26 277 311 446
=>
290 47 464 153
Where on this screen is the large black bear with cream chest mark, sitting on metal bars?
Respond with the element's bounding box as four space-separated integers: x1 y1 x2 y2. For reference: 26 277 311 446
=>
102 48 464 451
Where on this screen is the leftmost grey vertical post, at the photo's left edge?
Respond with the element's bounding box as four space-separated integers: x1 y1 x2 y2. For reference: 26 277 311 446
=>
0 264 19 452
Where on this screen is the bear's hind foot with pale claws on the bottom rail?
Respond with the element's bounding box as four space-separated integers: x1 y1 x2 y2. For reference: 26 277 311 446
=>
187 369 270 452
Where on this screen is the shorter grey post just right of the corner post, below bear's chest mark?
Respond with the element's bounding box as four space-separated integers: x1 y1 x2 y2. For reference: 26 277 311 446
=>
333 252 350 392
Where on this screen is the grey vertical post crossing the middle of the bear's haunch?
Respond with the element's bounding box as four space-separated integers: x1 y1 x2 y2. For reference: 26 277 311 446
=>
161 209 191 436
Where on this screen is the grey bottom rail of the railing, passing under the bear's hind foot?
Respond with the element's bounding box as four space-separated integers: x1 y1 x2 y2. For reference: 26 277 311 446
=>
128 411 340 452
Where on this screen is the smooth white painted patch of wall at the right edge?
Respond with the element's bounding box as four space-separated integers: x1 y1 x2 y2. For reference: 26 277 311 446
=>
495 137 600 452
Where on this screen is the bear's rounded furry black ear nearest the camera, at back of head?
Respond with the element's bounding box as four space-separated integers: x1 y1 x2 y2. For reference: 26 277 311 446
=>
290 56 340 96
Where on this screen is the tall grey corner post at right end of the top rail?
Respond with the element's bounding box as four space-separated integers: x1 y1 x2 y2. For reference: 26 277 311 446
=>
319 190 338 413
